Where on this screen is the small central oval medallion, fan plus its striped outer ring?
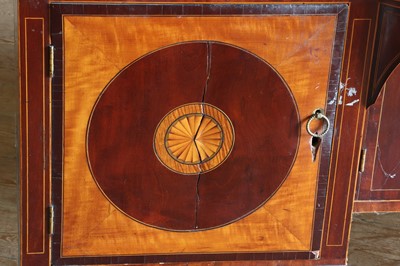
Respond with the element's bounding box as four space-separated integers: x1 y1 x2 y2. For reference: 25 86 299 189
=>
153 103 235 175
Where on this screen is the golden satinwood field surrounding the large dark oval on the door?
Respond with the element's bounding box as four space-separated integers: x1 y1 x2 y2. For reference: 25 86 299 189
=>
62 15 335 256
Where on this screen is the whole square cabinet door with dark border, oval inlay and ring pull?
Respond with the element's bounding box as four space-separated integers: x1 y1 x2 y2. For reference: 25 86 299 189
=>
47 4 347 265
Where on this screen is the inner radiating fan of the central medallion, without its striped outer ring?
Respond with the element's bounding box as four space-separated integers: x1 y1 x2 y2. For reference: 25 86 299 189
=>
165 114 223 164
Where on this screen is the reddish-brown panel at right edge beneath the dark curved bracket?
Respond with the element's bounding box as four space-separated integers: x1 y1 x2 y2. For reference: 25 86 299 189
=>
355 62 400 212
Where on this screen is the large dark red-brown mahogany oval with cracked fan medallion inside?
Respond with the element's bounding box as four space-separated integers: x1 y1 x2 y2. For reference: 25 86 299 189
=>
87 41 300 231
